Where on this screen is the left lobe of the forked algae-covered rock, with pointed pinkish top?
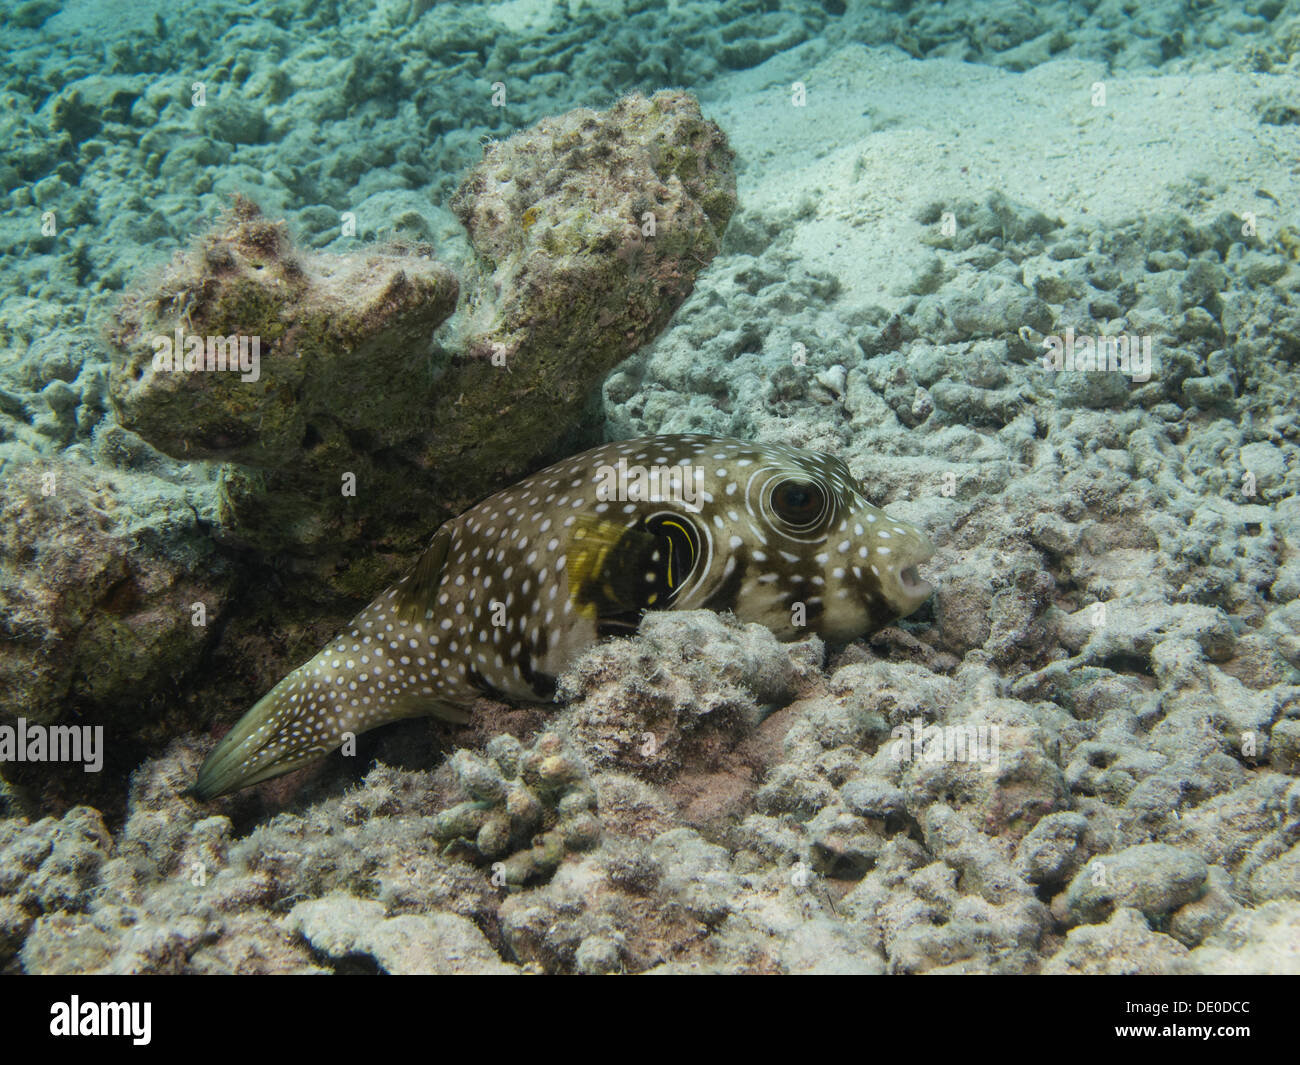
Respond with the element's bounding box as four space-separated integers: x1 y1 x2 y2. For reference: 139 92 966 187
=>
112 199 458 471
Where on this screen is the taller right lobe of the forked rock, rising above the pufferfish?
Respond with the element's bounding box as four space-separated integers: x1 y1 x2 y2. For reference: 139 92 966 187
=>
425 91 736 499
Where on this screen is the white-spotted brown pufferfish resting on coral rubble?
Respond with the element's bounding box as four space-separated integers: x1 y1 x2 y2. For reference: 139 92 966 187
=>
195 433 933 798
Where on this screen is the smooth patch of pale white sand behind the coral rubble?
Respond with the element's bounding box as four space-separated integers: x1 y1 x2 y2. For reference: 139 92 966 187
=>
705 46 1300 307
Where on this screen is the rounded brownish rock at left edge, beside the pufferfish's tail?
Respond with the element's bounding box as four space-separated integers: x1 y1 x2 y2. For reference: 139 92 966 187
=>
0 462 233 743
